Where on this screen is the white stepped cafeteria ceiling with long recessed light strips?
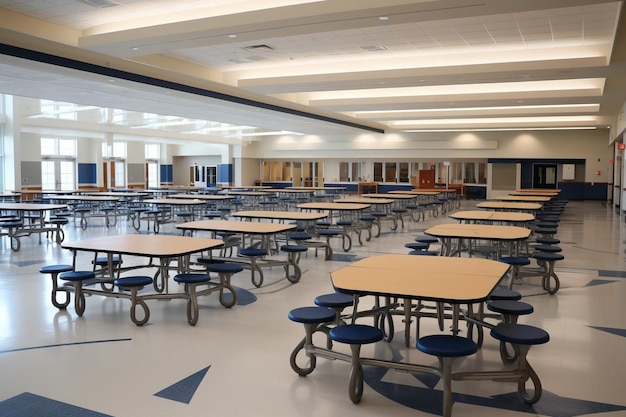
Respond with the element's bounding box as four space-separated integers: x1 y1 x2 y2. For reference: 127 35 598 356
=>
0 0 626 142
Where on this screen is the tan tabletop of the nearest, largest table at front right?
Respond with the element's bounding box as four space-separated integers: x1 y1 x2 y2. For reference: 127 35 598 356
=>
331 254 509 304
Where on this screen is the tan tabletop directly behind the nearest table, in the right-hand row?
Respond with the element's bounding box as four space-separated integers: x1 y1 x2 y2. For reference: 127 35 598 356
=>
424 223 531 241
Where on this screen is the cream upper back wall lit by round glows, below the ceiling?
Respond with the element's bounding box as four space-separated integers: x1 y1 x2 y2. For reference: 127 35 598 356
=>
243 130 613 182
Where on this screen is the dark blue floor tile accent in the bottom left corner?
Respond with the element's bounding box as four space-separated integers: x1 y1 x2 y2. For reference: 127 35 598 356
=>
0 392 112 417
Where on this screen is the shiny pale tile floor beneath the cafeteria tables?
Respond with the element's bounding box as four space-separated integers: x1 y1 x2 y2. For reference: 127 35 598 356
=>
0 201 626 417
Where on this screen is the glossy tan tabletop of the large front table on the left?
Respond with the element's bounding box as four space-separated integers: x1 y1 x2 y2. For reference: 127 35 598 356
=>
61 235 224 258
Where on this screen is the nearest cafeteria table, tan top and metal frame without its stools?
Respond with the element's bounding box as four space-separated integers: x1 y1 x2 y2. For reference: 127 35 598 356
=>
290 254 542 416
